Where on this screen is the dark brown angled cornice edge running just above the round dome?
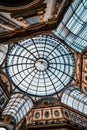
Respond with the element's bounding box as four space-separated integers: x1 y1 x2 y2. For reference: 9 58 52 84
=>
0 0 72 44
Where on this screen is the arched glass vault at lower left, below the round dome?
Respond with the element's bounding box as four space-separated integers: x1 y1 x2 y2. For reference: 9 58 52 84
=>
2 93 33 124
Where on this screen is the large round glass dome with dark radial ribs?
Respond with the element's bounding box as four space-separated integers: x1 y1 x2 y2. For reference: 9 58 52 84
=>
6 35 74 96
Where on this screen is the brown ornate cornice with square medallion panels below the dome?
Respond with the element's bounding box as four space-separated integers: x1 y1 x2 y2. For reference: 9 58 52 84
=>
26 100 87 130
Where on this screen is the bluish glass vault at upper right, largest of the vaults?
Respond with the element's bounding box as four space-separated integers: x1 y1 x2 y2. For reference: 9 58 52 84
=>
53 0 87 52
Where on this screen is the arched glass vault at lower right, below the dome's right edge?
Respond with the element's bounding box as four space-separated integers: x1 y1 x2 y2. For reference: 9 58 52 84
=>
61 86 87 114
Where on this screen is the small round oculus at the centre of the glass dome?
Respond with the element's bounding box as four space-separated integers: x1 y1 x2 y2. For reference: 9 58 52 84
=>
35 59 48 71
